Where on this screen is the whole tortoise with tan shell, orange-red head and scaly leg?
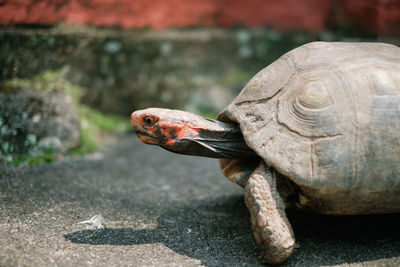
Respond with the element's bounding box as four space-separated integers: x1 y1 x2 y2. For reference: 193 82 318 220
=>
131 42 400 264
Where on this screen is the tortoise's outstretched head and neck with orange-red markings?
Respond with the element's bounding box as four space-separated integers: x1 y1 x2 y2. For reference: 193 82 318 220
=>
131 108 255 158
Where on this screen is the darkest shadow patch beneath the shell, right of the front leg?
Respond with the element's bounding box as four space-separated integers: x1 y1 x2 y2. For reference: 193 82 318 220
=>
287 212 400 265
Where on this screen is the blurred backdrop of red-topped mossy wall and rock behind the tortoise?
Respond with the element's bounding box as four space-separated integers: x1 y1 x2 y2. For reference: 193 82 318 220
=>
0 0 400 164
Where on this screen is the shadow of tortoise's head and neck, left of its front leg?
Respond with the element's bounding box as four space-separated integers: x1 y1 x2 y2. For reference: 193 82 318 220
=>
64 195 258 266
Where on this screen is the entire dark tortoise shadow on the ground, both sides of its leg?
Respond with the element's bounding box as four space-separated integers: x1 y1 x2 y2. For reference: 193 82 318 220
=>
64 195 400 266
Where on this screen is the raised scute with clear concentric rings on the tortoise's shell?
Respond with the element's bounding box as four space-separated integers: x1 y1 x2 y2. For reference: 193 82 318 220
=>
278 71 347 137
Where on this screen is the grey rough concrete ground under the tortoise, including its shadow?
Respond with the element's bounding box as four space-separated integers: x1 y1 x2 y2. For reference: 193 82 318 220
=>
0 135 400 266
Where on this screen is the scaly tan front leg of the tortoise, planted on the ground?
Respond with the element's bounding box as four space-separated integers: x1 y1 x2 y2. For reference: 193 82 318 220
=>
244 162 295 264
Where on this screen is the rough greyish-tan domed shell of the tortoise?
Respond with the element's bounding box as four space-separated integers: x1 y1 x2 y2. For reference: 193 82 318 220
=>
220 42 400 214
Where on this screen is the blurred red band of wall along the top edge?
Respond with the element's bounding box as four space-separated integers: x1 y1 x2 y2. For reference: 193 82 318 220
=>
0 0 400 35
